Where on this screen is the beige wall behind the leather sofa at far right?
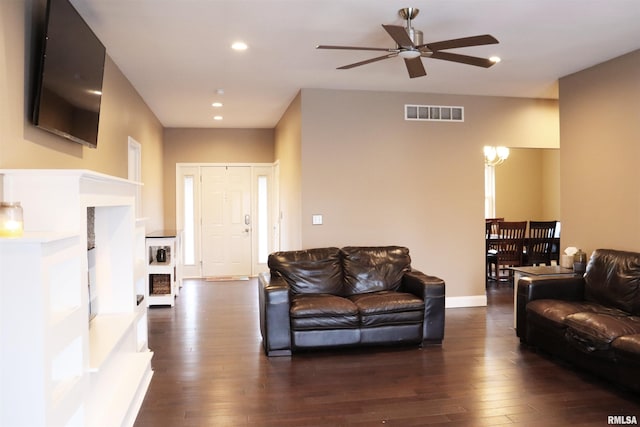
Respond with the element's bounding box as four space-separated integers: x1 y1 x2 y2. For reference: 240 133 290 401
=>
560 50 640 253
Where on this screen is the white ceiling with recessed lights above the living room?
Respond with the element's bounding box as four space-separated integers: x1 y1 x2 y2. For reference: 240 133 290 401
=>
72 0 640 128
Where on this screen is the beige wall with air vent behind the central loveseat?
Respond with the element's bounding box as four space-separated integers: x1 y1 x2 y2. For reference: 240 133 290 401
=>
301 89 559 304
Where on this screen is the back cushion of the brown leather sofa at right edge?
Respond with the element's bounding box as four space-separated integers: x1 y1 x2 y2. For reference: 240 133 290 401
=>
584 249 640 315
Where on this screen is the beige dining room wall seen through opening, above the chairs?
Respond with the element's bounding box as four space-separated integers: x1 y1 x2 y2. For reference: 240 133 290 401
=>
495 148 560 221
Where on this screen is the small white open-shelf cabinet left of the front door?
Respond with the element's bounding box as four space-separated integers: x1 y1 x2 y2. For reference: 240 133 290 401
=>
145 230 182 307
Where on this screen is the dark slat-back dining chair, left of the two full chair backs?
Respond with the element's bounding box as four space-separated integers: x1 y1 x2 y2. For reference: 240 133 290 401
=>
487 221 527 281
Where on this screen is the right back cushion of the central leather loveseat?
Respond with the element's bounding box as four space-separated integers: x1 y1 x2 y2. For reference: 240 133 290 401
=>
342 246 411 295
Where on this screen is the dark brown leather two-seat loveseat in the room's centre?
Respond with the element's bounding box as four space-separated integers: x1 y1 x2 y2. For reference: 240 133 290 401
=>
258 246 445 356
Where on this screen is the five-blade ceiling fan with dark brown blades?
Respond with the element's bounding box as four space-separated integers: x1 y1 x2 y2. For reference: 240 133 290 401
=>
316 7 498 78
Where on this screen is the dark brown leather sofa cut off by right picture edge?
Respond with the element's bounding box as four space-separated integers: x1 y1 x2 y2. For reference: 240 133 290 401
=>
516 249 640 391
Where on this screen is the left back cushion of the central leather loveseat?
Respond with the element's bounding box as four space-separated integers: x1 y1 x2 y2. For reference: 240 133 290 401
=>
267 248 343 295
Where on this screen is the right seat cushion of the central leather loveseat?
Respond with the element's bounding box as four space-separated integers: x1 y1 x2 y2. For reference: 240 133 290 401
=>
349 291 424 328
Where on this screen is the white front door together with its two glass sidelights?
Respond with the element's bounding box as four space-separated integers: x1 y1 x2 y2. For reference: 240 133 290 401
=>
176 164 278 278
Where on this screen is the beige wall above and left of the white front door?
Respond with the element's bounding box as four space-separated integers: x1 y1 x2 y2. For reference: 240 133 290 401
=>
162 128 274 228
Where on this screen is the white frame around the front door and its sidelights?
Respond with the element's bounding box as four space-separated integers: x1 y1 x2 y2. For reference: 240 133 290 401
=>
175 163 280 278
